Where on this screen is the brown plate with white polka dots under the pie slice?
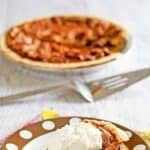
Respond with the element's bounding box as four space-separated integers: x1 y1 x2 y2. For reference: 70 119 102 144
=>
1 117 149 150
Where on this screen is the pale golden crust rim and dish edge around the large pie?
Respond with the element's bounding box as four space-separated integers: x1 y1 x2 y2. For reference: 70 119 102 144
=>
0 19 132 71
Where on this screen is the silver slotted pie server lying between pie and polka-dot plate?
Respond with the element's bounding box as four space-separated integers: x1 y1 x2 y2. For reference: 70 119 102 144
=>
0 68 150 104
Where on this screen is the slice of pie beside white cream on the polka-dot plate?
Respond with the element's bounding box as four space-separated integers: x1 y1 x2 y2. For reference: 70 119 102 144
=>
83 119 129 150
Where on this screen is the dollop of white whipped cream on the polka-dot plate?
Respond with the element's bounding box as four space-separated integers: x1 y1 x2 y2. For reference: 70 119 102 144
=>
48 122 102 150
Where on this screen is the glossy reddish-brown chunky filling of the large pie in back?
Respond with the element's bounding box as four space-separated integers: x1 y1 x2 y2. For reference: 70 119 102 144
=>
6 16 126 63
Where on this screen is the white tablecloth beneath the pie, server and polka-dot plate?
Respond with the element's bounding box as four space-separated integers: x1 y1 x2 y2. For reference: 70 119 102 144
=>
0 0 150 138
